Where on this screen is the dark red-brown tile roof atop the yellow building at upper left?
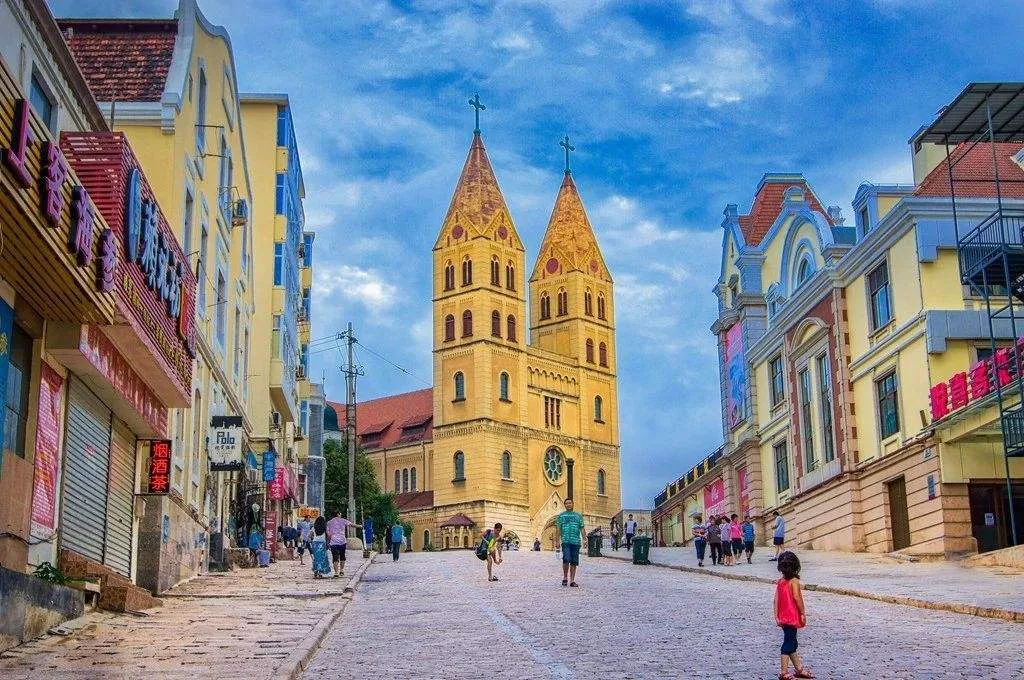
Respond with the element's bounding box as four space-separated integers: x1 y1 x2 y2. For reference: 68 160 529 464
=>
57 19 178 101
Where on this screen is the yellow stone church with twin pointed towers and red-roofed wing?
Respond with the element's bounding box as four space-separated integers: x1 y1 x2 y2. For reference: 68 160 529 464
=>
326 115 620 550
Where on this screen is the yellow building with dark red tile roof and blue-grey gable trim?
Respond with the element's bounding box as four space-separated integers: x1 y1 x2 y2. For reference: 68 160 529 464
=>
58 0 258 592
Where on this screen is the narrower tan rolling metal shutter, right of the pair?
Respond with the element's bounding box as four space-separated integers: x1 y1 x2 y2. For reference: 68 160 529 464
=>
103 418 135 578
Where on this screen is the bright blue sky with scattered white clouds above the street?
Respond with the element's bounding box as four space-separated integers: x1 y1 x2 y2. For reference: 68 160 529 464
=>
50 0 1024 507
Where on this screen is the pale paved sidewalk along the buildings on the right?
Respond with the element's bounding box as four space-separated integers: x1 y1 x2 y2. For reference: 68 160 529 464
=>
602 546 1024 622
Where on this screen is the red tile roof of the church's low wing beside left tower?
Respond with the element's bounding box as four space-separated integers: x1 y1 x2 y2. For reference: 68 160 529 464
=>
327 388 434 449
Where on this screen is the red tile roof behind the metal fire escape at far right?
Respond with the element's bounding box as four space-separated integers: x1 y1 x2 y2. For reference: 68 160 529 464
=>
913 142 1024 199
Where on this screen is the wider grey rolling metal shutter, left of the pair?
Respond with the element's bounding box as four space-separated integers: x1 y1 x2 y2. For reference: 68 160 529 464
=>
60 376 111 562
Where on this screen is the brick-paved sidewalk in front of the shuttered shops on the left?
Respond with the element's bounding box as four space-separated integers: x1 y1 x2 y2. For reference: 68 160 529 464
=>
0 554 370 680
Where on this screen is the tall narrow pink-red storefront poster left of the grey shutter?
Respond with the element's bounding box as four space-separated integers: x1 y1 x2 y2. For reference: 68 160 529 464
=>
32 362 63 539
